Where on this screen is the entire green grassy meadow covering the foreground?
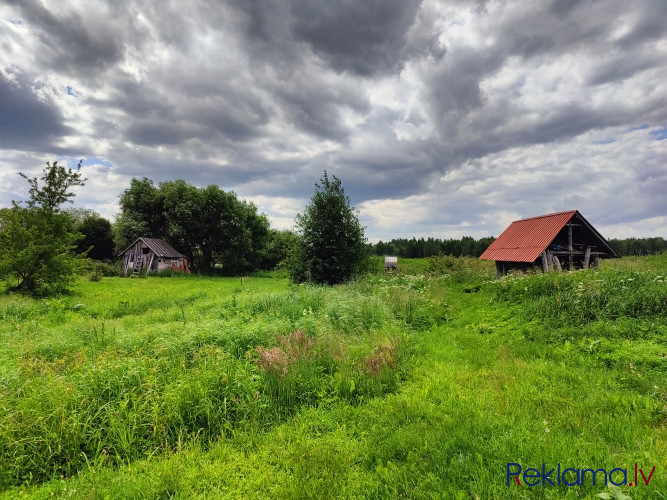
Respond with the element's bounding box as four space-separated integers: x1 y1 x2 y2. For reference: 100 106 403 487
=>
0 255 667 499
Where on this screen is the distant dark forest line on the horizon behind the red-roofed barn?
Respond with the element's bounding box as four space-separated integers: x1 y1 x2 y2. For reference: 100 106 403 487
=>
371 236 667 259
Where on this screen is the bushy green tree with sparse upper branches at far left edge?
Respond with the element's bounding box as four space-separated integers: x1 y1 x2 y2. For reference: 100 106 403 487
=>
0 162 85 296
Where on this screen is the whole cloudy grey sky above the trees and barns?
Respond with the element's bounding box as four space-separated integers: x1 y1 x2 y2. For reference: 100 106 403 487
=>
0 0 667 242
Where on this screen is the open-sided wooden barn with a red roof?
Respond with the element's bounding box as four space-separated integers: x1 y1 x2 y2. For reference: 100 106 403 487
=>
479 210 620 276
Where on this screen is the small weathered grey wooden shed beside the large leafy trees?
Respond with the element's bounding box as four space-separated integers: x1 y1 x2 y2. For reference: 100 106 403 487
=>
121 237 190 276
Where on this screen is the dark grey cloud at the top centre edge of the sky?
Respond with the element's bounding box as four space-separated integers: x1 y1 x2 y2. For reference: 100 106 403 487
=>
232 0 445 77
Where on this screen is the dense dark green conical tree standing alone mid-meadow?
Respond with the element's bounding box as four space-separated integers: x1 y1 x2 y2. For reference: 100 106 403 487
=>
288 171 368 285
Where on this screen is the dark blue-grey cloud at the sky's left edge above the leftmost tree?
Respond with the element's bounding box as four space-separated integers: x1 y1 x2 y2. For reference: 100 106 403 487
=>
0 75 74 150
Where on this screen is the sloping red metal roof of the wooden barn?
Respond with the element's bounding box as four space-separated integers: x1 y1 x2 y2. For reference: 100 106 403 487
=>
479 210 577 262
